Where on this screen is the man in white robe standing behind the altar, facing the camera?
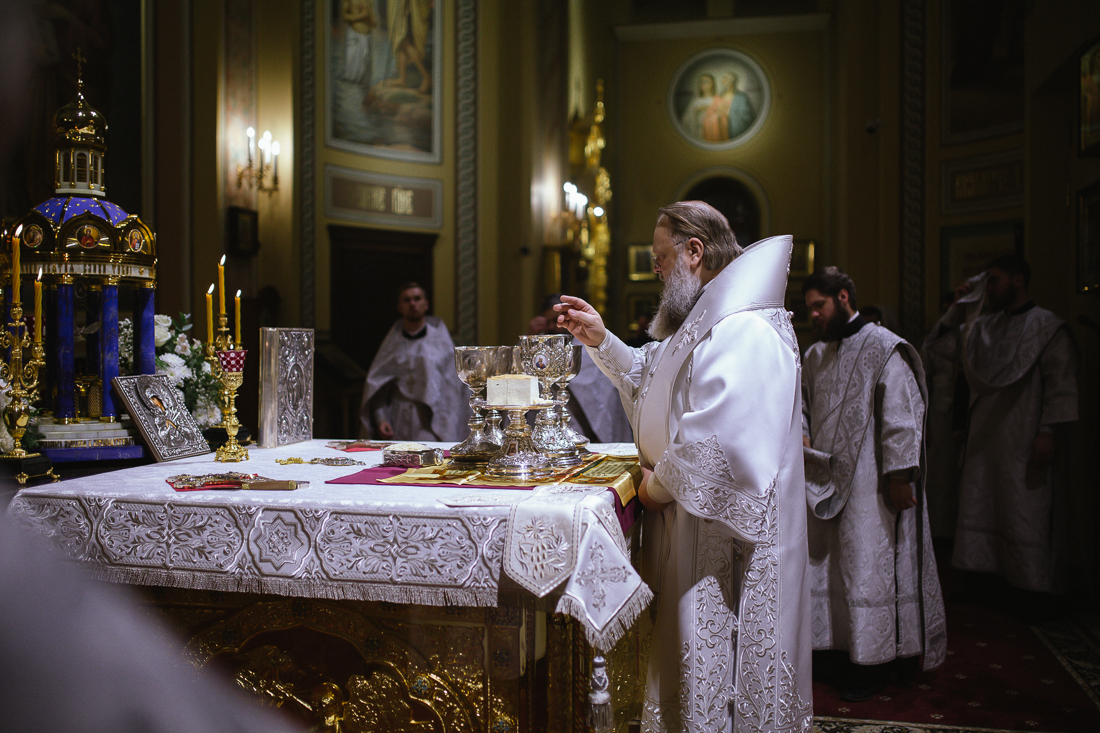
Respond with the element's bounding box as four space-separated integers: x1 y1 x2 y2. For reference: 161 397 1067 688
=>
360 283 470 441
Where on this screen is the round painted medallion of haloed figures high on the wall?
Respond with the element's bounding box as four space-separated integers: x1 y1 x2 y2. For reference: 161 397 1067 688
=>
669 48 771 150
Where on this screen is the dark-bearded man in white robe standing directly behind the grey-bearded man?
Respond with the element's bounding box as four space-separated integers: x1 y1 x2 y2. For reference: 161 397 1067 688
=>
802 267 947 702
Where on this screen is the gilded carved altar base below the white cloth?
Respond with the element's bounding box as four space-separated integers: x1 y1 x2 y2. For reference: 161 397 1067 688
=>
140 587 648 733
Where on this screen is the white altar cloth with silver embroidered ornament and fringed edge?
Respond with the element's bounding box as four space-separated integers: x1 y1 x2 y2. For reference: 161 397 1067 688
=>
9 440 651 650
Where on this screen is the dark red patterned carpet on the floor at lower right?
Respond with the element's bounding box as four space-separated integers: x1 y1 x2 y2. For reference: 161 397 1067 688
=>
814 603 1100 733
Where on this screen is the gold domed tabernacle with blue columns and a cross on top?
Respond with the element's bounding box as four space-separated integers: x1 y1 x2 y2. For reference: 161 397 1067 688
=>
3 50 156 442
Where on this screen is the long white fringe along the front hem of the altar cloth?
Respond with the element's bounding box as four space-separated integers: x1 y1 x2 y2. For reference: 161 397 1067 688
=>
85 566 499 608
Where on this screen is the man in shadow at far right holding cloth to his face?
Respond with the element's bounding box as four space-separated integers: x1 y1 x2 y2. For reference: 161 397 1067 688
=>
934 255 1077 592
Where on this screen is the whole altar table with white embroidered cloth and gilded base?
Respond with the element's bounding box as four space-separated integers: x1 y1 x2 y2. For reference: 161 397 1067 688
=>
9 440 650 733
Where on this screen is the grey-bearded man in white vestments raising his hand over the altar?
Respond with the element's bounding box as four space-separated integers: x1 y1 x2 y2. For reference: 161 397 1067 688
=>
557 201 812 733
